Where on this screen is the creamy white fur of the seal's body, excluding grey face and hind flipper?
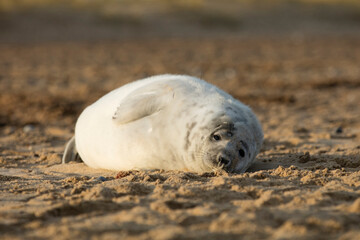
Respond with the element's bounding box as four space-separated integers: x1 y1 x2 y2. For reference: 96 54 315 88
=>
75 75 263 172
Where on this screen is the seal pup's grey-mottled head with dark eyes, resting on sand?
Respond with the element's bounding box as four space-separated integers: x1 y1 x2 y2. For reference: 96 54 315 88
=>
195 108 263 173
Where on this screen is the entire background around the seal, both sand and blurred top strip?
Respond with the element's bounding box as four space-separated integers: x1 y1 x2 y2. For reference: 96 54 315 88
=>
0 0 360 239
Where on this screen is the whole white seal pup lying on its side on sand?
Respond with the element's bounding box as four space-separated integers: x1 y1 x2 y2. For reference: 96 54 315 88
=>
63 75 263 172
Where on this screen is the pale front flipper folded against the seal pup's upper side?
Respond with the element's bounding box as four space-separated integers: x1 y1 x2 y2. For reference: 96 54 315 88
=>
113 83 175 124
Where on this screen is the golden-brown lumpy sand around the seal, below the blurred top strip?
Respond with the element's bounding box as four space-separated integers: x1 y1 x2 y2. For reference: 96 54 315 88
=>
0 9 360 239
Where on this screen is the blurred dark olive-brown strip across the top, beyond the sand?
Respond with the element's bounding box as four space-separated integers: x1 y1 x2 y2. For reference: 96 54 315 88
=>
0 0 360 42
